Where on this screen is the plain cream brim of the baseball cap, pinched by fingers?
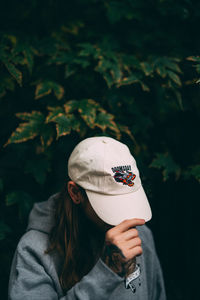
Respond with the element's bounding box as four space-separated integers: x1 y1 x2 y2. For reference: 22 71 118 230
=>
86 185 152 225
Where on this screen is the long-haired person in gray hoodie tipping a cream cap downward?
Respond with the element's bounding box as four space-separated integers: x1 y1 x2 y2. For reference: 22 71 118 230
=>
8 136 166 300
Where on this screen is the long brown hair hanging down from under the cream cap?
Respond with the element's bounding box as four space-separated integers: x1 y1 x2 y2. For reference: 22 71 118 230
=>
44 177 102 292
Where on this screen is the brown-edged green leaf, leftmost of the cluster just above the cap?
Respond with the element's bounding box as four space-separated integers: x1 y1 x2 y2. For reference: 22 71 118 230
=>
3 111 45 147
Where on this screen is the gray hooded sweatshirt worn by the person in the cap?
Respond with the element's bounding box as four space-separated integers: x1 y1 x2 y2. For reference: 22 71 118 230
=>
8 194 166 300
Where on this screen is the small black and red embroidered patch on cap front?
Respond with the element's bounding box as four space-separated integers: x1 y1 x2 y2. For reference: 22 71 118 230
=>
112 165 136 186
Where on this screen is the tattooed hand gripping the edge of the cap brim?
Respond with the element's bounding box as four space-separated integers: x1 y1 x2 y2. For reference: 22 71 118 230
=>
101 218 145 277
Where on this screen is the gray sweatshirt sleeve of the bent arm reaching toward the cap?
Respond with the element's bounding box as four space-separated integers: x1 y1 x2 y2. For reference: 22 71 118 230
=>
8 241 123 300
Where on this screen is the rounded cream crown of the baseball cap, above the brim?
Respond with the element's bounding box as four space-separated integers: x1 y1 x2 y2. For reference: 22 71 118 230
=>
68 136 141 195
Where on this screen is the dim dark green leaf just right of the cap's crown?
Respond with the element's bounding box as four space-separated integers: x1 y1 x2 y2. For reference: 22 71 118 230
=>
150 153 181 181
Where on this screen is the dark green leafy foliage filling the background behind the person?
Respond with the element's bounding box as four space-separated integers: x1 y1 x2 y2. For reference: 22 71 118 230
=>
0 0 200 300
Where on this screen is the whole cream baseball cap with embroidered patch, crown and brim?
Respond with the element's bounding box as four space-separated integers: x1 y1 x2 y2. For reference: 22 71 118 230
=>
68 136 152 225
